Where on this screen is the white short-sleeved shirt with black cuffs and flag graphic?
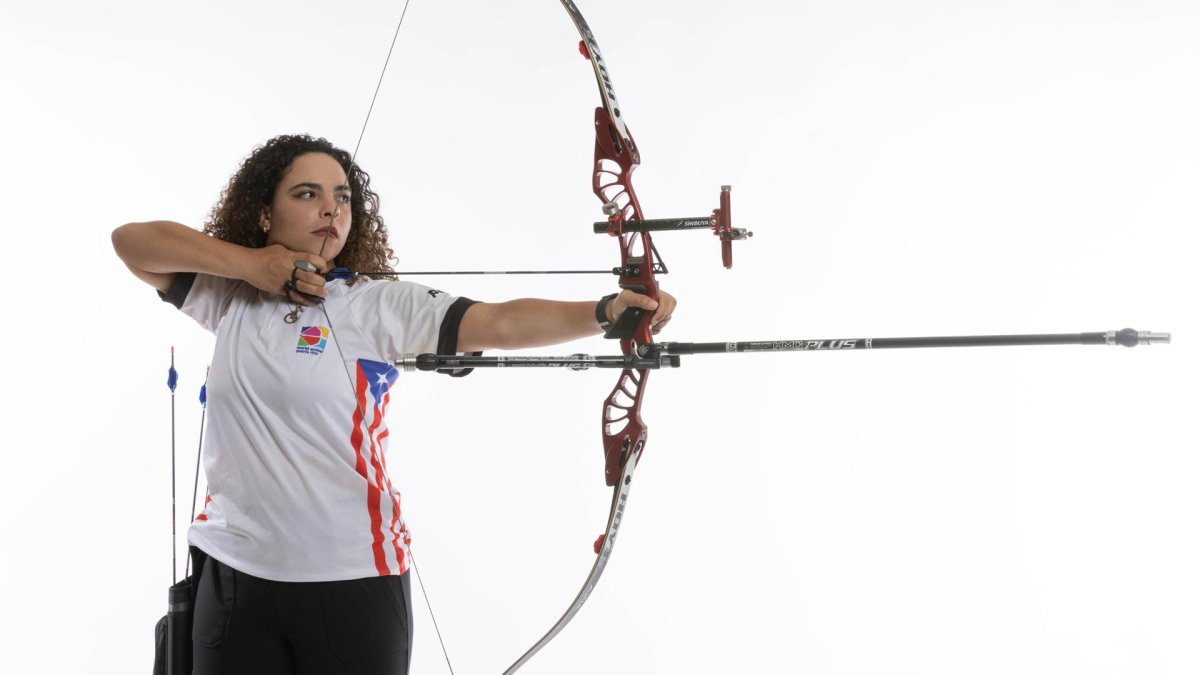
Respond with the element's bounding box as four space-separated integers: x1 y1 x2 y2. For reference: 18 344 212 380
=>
164 274 470 581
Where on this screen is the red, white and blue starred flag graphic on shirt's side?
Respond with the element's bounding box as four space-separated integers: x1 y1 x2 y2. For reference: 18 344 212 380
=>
350 359 408 577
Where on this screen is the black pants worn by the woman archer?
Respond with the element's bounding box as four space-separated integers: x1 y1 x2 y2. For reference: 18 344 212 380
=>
192 550 413 675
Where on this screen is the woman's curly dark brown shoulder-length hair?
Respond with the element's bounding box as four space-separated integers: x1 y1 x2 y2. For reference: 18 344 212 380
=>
204 135 396 271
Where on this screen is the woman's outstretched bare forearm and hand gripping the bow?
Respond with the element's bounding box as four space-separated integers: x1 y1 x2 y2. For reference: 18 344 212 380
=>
458 291 676 352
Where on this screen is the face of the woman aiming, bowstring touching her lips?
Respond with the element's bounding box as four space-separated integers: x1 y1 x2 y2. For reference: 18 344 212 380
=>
260 153 352 262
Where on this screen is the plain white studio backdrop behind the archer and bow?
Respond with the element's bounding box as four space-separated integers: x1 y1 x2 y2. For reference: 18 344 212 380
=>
0 0 1200 675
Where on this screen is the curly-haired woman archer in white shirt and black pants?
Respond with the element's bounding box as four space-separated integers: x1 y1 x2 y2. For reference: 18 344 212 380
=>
113 136 676 675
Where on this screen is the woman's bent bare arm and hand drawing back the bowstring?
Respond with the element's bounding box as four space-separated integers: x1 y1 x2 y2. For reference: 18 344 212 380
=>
113 220 325 299
